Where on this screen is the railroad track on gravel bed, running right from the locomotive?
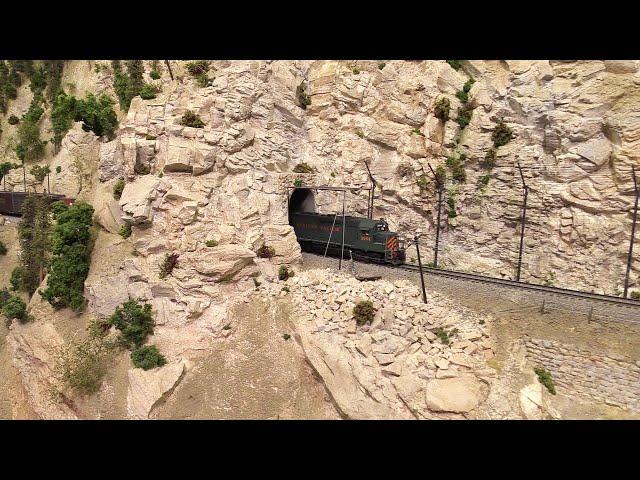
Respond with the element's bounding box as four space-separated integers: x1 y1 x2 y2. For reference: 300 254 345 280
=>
305 252 640 324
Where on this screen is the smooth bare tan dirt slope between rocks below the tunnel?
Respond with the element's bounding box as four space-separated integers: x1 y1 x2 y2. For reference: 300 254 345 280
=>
151 297 340 419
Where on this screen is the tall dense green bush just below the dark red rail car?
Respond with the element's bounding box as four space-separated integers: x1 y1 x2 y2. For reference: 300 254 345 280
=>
40 201 94 311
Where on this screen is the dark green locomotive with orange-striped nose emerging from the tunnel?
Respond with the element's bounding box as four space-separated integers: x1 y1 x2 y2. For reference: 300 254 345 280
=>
290 212 405 265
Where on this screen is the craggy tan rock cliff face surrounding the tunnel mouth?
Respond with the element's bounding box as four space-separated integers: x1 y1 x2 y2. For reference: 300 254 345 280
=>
0 61 640 418
